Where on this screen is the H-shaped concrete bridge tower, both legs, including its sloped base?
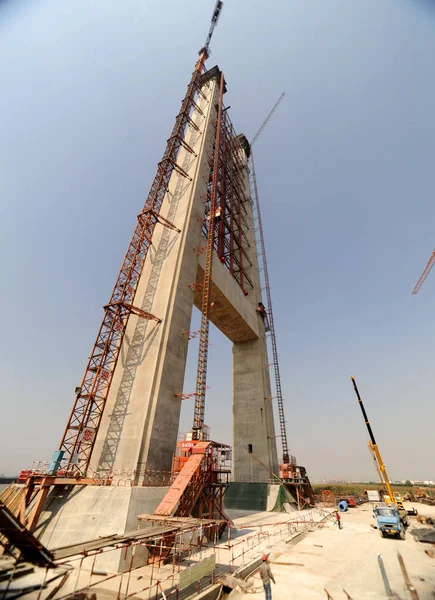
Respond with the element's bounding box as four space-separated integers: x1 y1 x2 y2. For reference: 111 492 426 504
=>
37 67 278 571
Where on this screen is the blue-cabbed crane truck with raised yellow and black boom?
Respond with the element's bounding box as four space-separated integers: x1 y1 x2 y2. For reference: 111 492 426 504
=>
351 377 409 539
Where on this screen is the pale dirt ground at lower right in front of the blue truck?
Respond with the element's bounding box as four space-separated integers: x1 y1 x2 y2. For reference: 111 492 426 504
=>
238 503 435 600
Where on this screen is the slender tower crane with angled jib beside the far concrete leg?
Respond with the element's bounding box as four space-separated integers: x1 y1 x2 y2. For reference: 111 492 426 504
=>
251 92 290 465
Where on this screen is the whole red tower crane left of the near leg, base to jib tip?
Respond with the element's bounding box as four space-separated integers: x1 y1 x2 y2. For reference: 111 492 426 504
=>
14 0 227 531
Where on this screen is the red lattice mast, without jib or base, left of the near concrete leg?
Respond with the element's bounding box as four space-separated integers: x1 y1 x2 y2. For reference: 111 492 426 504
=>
59 51 211 474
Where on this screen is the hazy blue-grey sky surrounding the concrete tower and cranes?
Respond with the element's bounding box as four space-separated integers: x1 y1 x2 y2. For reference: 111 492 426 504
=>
0 0 435 480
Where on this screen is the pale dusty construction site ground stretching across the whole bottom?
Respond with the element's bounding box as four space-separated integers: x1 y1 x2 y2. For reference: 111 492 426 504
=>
0 503 435 600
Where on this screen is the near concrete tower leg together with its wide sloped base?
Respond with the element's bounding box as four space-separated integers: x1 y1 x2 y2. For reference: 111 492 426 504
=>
36 75 220 571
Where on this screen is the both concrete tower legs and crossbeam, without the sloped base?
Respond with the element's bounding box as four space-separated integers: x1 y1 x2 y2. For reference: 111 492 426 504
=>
90 71 278 485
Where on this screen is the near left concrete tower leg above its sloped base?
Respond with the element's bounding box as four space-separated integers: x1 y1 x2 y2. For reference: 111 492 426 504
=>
91 74 218 478
